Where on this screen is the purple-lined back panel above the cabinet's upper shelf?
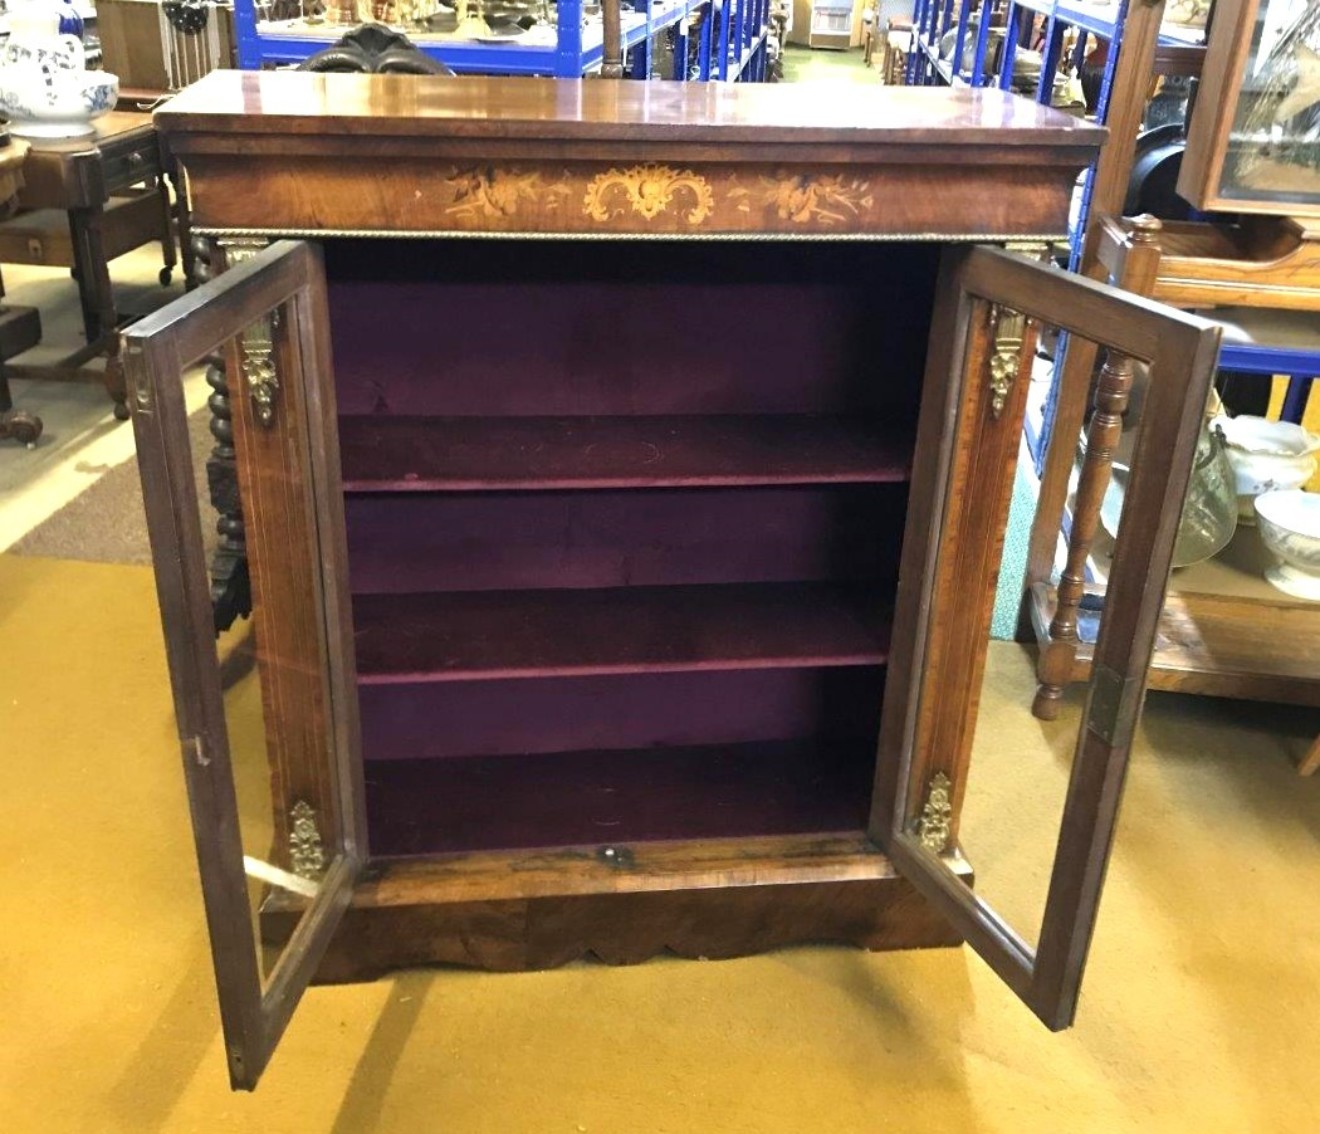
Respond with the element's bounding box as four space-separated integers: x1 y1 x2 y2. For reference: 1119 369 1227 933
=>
331 283 884 417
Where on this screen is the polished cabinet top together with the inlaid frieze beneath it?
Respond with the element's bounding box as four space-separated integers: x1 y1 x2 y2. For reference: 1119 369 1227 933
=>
156 71 1104 239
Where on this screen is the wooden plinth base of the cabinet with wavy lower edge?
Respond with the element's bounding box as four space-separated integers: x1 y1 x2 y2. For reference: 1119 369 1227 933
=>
273 834 972 984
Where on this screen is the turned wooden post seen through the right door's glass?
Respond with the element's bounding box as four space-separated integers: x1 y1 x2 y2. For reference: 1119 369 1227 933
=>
1031 350 1133 721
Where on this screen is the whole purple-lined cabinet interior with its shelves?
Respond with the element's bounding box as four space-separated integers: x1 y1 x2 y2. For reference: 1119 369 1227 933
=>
326 240 939 857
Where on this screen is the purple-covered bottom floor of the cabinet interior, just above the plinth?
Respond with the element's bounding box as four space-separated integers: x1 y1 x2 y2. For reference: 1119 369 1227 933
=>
366 739 874 865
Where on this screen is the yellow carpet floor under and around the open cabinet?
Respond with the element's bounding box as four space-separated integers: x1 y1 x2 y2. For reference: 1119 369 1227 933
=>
0 556 1320 1134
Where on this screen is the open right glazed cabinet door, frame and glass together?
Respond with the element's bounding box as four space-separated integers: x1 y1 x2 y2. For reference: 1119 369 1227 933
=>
871 248 1218 1030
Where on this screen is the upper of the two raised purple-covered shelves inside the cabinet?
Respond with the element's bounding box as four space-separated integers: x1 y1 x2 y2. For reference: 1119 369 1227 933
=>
339 415 911 492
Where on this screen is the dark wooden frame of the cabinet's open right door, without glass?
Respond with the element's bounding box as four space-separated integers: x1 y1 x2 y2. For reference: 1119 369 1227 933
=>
870 248 1220 1030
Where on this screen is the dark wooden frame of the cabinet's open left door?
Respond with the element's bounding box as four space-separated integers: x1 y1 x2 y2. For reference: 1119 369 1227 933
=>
123 242 366 1089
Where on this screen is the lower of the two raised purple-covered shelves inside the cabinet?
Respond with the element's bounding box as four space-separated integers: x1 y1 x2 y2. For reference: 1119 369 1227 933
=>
354 584 890 685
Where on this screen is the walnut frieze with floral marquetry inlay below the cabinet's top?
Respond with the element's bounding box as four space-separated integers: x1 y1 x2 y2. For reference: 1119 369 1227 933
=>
178 153 1080 239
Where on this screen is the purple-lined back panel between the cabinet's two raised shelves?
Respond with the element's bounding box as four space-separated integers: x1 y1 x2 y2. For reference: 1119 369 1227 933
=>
346 484 907 597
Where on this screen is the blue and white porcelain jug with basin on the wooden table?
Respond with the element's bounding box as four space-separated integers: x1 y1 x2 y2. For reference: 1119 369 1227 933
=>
0 0 119 137
